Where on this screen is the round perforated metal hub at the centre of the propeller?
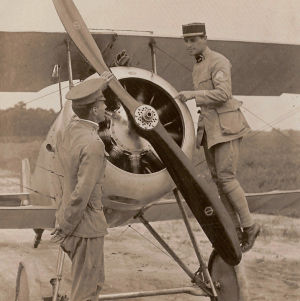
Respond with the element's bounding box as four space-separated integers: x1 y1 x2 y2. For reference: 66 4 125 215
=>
134 105 159 130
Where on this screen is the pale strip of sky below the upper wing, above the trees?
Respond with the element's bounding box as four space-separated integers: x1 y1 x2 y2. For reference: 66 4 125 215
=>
0 81 300 131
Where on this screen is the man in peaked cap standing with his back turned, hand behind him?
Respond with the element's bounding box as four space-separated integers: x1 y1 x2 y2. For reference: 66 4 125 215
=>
53 71 113 301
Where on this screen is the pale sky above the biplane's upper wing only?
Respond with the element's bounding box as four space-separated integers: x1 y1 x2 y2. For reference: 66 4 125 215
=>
0 0 300 44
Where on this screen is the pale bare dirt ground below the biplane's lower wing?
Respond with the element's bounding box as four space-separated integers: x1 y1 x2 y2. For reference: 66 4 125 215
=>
0 215 300 301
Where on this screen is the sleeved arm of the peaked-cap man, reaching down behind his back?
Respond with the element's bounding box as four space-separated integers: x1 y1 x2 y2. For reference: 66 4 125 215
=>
59 141 104 235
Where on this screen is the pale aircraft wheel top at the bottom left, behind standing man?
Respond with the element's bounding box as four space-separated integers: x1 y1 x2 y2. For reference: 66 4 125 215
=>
15 260 43 301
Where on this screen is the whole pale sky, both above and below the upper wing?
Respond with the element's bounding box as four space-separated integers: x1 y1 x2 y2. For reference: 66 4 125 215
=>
0 0 300 130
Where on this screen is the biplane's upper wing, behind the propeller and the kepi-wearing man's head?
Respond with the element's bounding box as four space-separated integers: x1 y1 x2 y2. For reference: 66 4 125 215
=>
0 31 300 96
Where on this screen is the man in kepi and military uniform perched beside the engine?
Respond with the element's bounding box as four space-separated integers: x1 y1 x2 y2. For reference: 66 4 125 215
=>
176 23 260 252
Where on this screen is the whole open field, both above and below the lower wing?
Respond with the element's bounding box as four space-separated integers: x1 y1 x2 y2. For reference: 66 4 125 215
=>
0 132 300 301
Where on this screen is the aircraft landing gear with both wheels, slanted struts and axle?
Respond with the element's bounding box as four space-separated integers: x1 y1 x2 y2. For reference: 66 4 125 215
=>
15 190 249 301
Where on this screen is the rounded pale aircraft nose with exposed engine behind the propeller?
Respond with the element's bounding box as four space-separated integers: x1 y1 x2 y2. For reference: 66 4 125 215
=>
32 67 195 227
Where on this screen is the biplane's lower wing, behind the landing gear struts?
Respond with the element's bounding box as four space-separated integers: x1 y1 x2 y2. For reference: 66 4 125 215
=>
0 190 300 229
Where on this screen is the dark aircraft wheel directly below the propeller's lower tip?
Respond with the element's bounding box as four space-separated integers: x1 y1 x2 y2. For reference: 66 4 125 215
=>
208 250 241 301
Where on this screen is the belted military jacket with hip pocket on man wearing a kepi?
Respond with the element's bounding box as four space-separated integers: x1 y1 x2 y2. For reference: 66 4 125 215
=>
193 47 250 148
